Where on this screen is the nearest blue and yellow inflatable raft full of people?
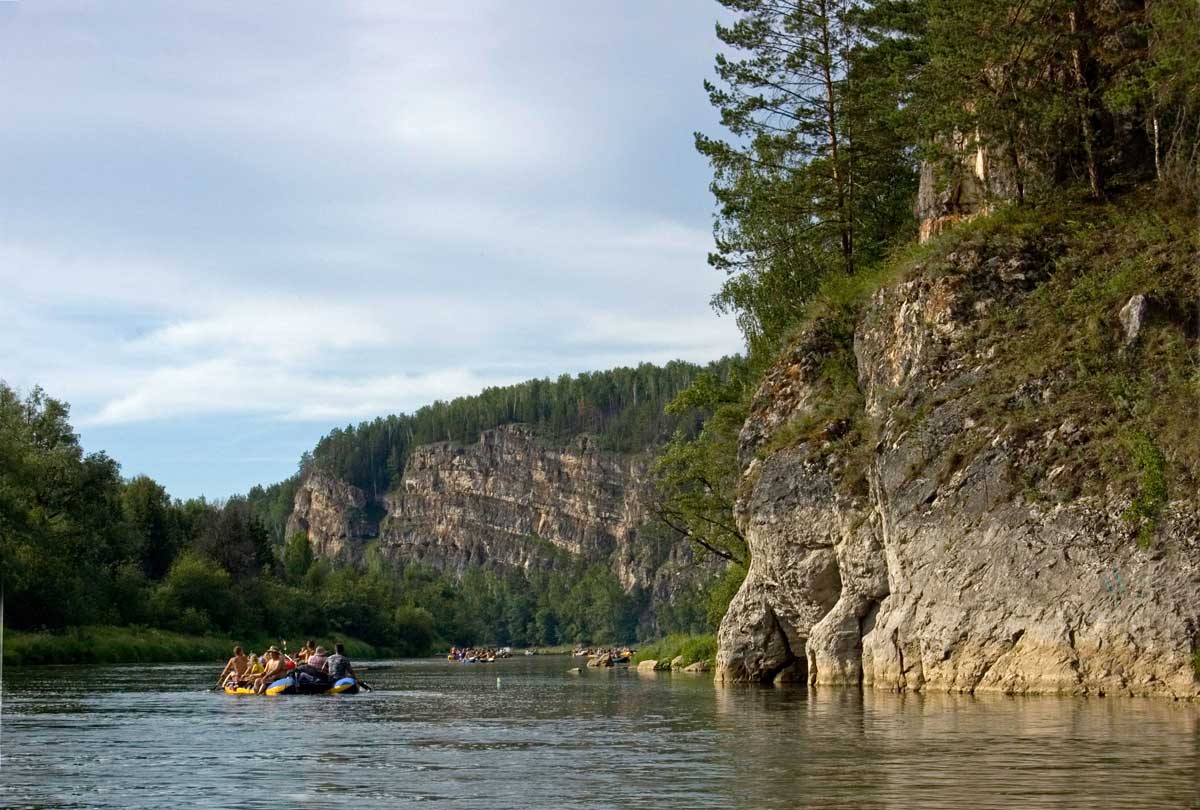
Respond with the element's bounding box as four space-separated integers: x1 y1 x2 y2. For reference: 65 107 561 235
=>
217 641 370 695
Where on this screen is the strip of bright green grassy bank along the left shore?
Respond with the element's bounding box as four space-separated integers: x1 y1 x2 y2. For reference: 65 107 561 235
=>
4 625 388 665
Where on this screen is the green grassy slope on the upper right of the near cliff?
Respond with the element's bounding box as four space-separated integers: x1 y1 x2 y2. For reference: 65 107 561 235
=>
945 192 1200 516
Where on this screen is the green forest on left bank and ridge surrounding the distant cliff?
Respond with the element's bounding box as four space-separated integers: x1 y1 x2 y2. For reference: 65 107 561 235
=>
0 359 737 655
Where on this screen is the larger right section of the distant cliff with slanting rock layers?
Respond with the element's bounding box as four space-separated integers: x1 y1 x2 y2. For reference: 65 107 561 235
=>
382 425 654 589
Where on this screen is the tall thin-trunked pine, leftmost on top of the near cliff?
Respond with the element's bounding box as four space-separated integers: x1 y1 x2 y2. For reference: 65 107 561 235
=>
696 0 912 357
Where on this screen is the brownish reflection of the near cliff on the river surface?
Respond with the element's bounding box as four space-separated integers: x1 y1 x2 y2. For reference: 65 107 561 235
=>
715 685 1200 809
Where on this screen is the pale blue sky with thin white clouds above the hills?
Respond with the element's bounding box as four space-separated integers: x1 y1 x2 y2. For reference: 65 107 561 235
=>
0 0 740 498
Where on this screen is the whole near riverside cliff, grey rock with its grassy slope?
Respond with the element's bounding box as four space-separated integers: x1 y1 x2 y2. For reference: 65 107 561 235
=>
718 193 1200 697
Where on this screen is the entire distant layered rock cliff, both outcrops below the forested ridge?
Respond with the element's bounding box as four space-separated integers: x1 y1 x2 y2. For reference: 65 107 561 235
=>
288 425 712 598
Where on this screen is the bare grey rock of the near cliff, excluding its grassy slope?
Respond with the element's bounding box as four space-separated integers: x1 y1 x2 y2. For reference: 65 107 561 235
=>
718 234 1200 697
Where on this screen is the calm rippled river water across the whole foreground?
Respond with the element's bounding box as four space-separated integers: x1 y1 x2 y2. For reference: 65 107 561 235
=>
0 656 1200 810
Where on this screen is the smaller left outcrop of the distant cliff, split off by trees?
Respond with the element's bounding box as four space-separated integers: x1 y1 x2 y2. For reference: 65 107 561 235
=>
287 472 378 563
